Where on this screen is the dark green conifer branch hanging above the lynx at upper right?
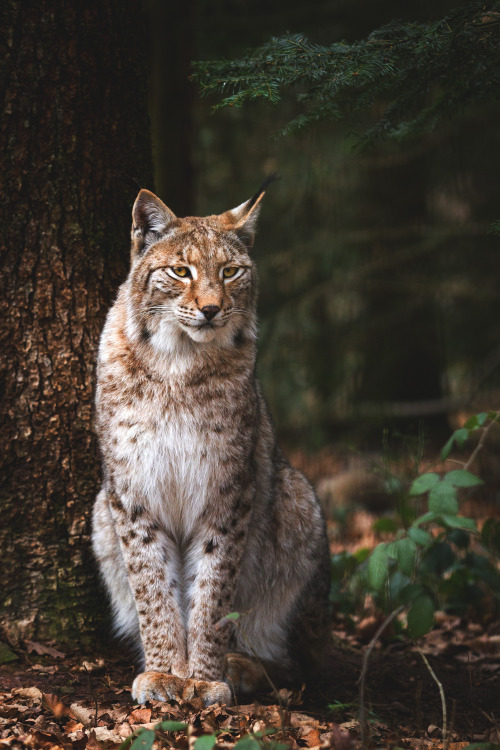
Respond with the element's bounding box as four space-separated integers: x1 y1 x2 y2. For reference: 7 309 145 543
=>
193 1 500 141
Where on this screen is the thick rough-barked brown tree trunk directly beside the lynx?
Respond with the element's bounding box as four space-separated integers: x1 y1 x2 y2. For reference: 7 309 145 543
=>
0 0 152 644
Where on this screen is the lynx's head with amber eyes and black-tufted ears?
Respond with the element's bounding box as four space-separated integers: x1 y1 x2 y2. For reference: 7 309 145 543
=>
124 175 275 351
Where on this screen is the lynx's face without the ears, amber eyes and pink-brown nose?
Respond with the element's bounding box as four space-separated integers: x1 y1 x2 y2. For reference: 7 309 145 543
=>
132 219 255 350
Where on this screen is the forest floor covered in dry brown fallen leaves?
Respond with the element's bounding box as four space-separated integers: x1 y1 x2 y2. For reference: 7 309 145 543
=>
0 446 500 750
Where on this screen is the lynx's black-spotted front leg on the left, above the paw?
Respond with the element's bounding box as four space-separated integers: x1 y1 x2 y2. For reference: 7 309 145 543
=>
110 495 188 680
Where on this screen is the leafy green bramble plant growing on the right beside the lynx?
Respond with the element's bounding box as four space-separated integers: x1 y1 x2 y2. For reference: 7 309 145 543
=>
331 411 500 639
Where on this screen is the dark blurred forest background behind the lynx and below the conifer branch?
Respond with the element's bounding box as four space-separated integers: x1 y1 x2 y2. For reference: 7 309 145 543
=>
150 0 500 449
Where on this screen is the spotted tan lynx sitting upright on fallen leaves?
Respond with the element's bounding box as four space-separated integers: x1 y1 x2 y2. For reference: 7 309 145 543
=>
92 179 329 705
